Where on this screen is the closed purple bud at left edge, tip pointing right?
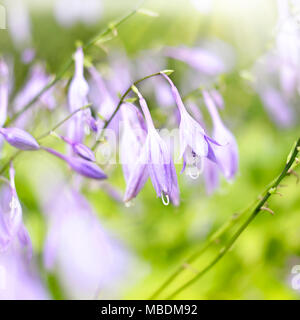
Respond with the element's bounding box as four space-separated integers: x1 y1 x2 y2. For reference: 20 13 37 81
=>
0 128 40 150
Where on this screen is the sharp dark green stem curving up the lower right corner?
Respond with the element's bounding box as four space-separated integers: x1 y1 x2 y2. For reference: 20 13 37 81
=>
167 138 300 299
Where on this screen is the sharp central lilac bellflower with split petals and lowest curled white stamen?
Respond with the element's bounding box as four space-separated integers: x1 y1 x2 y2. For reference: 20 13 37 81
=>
125 87 179 205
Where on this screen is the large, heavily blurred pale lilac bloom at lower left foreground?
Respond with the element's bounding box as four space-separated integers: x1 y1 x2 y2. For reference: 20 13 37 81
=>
44 187 130 299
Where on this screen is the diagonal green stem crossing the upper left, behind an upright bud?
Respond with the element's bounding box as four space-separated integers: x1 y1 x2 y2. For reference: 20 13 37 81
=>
5 1 144 126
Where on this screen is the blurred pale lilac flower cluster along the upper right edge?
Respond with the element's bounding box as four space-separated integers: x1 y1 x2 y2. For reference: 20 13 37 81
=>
253 0 300 128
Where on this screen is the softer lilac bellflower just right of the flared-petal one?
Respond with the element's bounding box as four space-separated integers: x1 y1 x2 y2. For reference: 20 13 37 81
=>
203 91 238 180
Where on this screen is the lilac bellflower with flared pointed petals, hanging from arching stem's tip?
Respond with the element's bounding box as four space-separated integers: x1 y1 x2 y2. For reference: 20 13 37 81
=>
162 73 220 175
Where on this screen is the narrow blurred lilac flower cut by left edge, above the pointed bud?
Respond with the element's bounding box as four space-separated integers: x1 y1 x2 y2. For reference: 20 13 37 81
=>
0 59 9 127
